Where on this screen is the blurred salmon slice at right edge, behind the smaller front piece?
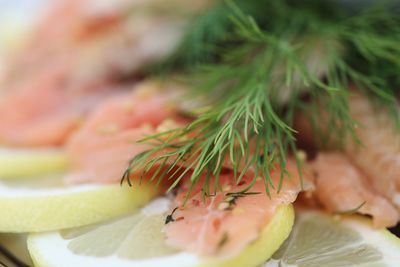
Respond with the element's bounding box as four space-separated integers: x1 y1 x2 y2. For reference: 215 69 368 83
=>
345 94 400 210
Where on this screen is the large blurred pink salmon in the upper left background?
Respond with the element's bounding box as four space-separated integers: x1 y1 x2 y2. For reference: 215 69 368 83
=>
0 0 211 149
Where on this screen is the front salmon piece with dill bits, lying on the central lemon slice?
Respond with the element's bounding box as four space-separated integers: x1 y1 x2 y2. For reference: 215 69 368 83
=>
165 160 308 257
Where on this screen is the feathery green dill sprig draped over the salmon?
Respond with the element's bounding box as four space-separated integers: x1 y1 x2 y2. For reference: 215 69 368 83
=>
124 1 400 199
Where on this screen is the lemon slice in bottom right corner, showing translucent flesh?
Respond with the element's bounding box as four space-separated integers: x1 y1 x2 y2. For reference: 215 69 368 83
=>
263 211 400 267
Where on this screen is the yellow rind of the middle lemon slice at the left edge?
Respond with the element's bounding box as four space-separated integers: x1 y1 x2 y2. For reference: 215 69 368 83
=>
0 184 157 233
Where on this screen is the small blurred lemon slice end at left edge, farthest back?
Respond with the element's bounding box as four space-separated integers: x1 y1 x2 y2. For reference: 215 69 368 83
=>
0 148 68 179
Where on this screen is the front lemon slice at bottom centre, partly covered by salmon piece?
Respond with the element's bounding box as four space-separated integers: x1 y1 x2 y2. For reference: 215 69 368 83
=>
28 198 294 267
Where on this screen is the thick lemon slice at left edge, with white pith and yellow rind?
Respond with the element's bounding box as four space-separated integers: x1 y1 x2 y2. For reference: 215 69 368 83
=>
0 176 157 233
